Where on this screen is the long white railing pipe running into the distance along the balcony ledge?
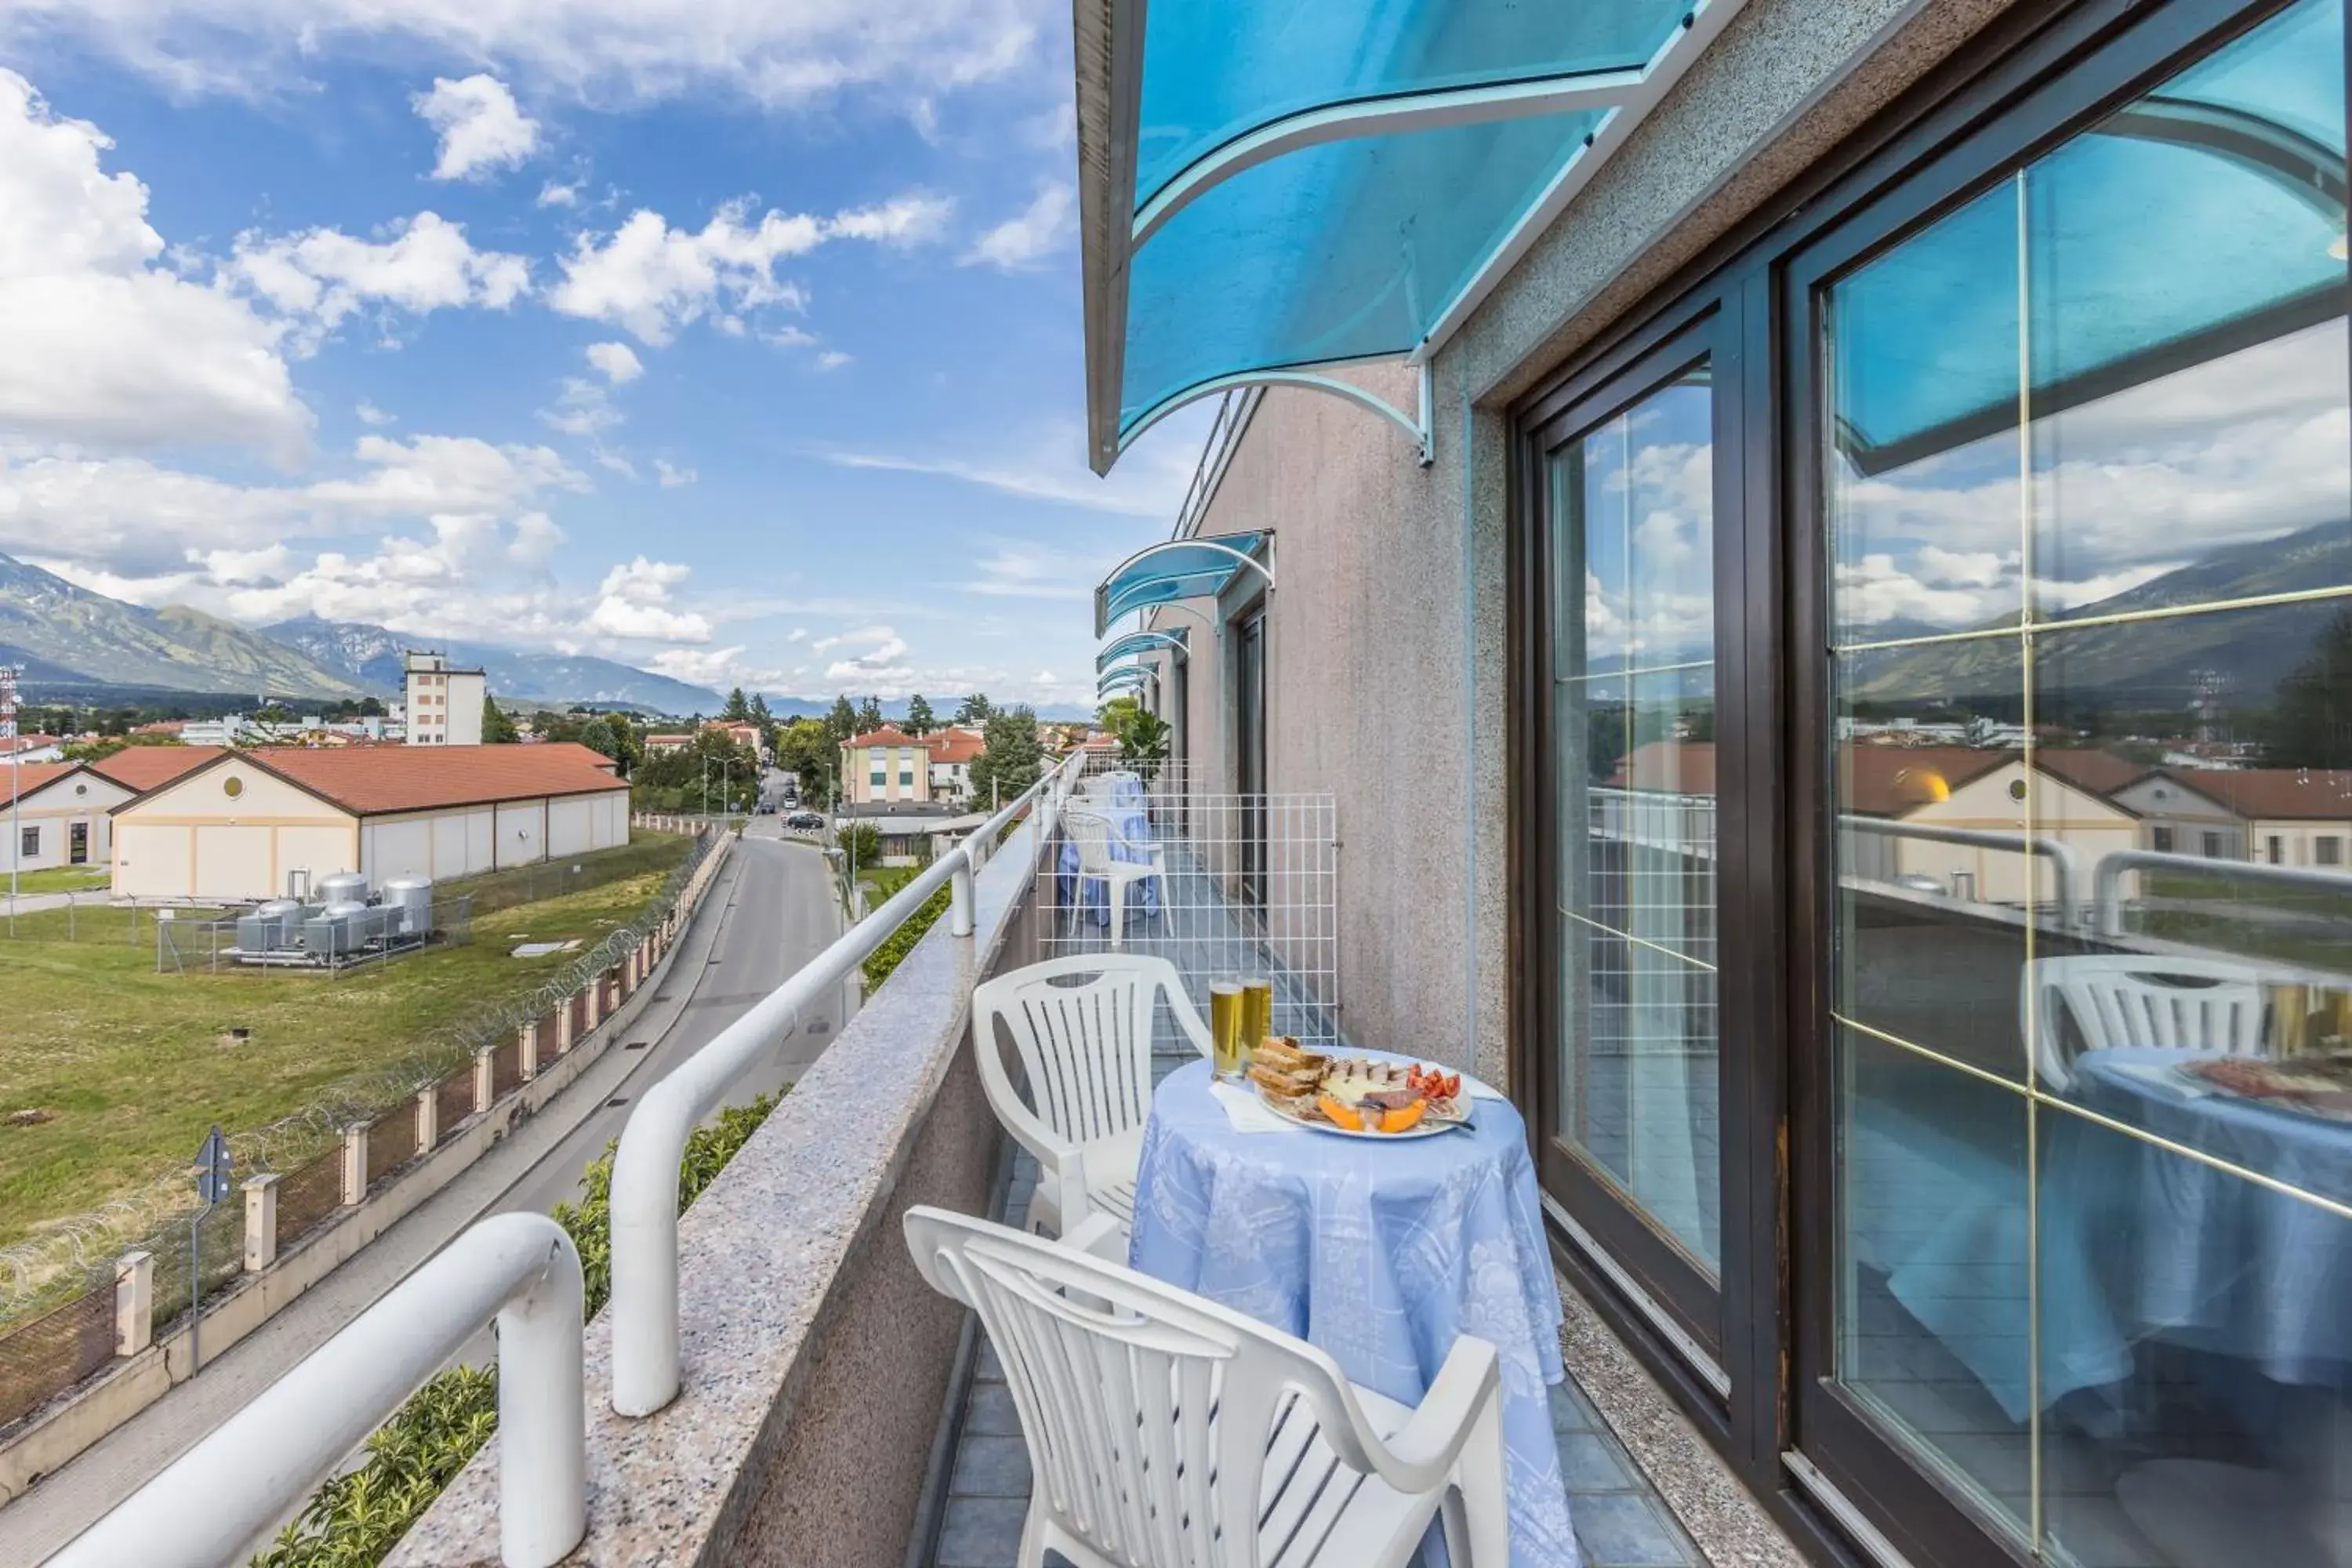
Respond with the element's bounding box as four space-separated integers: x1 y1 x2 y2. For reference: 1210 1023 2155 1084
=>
612 764 1068 1415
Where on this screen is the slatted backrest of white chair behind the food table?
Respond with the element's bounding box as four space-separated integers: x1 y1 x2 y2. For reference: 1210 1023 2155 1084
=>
971 952 1183 1147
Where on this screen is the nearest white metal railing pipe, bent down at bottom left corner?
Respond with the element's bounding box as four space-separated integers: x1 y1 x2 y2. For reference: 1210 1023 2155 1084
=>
49 1213 588 1568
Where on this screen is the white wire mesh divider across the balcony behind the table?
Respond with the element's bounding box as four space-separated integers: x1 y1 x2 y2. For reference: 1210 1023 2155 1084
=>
1044 780 1341 1044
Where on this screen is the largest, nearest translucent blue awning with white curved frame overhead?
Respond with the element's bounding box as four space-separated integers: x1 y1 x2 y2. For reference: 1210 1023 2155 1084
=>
1077 0 1740 473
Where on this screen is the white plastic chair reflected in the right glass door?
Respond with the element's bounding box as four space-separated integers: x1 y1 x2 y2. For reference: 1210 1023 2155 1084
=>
2018 952 2270 1093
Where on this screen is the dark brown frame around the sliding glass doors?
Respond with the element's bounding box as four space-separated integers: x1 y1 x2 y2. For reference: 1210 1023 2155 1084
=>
1508 0 2291 1568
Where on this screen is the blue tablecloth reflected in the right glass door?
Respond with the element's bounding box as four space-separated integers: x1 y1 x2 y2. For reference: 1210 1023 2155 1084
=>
1849 1046 2352 1420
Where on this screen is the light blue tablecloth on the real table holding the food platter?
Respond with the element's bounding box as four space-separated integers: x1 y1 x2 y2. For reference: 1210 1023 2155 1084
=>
1131 1062 1578 1568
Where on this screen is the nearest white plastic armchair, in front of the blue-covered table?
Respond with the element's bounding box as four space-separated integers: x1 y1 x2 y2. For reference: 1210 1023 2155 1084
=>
906 1208 1510 1568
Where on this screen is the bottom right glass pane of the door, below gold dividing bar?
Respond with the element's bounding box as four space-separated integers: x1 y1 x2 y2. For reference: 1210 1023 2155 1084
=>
2037 1109 2352 1568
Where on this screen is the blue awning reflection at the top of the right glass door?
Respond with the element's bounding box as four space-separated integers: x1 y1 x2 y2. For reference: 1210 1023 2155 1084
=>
1832 5 2347 473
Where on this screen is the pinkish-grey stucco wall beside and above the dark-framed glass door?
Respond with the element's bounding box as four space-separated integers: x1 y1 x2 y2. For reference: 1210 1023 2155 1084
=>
1171 0 2011 1081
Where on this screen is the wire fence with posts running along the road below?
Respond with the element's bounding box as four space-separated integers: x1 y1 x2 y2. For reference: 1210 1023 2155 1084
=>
0 832 720 1427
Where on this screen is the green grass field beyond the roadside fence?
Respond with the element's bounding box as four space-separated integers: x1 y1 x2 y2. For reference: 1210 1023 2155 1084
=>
0 839 687 1246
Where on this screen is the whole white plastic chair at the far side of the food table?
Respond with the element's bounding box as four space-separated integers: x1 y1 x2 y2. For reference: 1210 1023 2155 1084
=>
971 952 1211 1236
